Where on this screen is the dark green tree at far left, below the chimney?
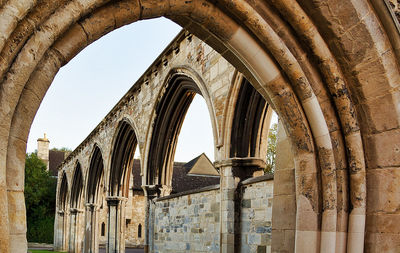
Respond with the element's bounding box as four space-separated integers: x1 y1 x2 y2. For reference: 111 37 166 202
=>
25 153 57 243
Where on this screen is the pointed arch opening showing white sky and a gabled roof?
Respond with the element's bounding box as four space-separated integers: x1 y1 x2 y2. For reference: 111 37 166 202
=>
170 94 219 194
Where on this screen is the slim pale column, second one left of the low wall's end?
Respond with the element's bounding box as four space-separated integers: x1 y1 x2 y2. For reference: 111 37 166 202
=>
83 203 98 253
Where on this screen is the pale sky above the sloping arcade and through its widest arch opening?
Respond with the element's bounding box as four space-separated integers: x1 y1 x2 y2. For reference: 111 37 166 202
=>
27 18 219 161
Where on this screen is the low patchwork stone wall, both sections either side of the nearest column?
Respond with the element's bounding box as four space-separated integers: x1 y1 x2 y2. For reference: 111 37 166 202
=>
154 175 273 252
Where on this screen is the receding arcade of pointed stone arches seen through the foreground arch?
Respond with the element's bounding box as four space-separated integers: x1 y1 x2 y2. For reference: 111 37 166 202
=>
55 31 276 252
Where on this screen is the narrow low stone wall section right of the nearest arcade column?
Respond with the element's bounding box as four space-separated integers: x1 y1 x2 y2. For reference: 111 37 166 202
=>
239 176 274 252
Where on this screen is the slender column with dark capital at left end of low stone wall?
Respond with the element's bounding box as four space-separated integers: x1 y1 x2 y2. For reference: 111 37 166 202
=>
142 185 162 253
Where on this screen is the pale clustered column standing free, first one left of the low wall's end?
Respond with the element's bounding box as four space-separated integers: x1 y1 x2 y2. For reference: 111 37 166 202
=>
106 196 127 253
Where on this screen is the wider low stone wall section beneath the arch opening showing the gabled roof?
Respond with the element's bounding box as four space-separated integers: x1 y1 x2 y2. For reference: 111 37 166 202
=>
154 186 220 253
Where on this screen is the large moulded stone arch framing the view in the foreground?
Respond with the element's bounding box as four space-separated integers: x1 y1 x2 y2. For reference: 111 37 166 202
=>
0 0 400 252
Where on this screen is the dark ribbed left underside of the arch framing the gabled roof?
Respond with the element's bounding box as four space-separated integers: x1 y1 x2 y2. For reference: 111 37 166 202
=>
148 75 201 187
